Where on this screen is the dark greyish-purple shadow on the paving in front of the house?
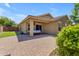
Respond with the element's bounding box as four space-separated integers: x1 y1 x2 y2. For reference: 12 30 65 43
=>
16 32 55 42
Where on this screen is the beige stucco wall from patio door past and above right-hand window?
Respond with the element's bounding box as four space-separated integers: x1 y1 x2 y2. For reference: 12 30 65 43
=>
43 19 67 34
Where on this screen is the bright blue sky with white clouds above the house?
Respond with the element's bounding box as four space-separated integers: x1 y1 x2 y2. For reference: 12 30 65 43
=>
0 3 74 24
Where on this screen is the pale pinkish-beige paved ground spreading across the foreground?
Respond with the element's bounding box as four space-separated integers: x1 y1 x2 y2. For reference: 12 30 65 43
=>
0 34 56 56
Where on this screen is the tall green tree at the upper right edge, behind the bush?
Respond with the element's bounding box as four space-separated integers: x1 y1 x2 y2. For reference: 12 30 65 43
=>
70 3 79 24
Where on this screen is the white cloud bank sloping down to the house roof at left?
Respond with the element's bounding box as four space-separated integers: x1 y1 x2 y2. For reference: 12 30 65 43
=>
0 7 27 23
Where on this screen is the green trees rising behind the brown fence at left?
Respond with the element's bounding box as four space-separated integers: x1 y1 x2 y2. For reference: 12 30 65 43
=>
0 16 16 26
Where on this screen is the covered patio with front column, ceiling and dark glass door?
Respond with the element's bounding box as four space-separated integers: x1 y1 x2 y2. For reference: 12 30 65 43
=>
29 18 53 36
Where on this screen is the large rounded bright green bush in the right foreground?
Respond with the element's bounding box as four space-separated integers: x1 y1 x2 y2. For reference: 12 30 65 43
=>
57 24 79 56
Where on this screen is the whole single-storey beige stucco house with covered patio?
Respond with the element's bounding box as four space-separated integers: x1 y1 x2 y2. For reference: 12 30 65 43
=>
19 13 68 36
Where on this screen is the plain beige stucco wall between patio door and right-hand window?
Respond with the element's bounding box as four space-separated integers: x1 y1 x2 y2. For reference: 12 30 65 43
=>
43 22 58 34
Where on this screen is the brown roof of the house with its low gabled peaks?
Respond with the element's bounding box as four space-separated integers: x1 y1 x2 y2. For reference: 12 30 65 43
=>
19 13 68 25
